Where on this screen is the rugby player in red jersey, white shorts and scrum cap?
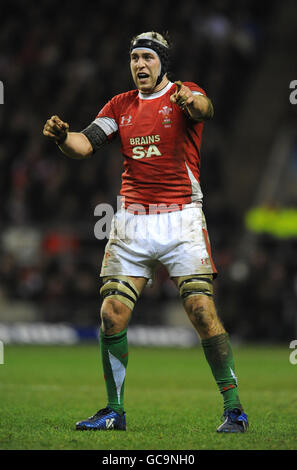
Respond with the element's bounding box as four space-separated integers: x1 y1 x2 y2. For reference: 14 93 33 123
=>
43 32 248 433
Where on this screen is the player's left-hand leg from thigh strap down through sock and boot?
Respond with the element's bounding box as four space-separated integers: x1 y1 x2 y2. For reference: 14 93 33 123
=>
76 276 147 430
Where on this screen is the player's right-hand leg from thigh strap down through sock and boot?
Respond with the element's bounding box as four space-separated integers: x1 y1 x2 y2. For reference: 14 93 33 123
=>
173 275 248 432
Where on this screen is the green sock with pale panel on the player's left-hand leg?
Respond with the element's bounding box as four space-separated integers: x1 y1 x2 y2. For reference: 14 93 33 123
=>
100 329 128 414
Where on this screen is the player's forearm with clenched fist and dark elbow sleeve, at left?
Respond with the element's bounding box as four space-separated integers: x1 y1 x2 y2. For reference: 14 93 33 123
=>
43 116 108 159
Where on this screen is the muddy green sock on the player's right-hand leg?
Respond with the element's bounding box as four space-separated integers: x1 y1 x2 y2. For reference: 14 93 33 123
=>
201 333 242 410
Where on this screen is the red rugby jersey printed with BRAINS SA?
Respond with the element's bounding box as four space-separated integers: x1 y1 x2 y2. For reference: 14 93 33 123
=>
94 82 205 211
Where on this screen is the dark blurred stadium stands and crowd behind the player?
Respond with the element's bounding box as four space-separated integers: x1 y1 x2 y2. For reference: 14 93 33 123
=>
0 0 297 345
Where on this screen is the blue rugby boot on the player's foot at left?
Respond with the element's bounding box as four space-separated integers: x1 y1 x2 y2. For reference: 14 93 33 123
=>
76 407 126 431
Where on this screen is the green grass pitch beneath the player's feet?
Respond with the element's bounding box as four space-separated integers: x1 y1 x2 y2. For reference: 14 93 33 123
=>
0 345 297 450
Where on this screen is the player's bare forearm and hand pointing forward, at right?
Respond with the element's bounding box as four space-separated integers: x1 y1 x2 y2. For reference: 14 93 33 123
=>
170 81 214 122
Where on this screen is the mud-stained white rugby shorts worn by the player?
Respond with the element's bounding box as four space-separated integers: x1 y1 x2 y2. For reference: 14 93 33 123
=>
100 203 217 279
